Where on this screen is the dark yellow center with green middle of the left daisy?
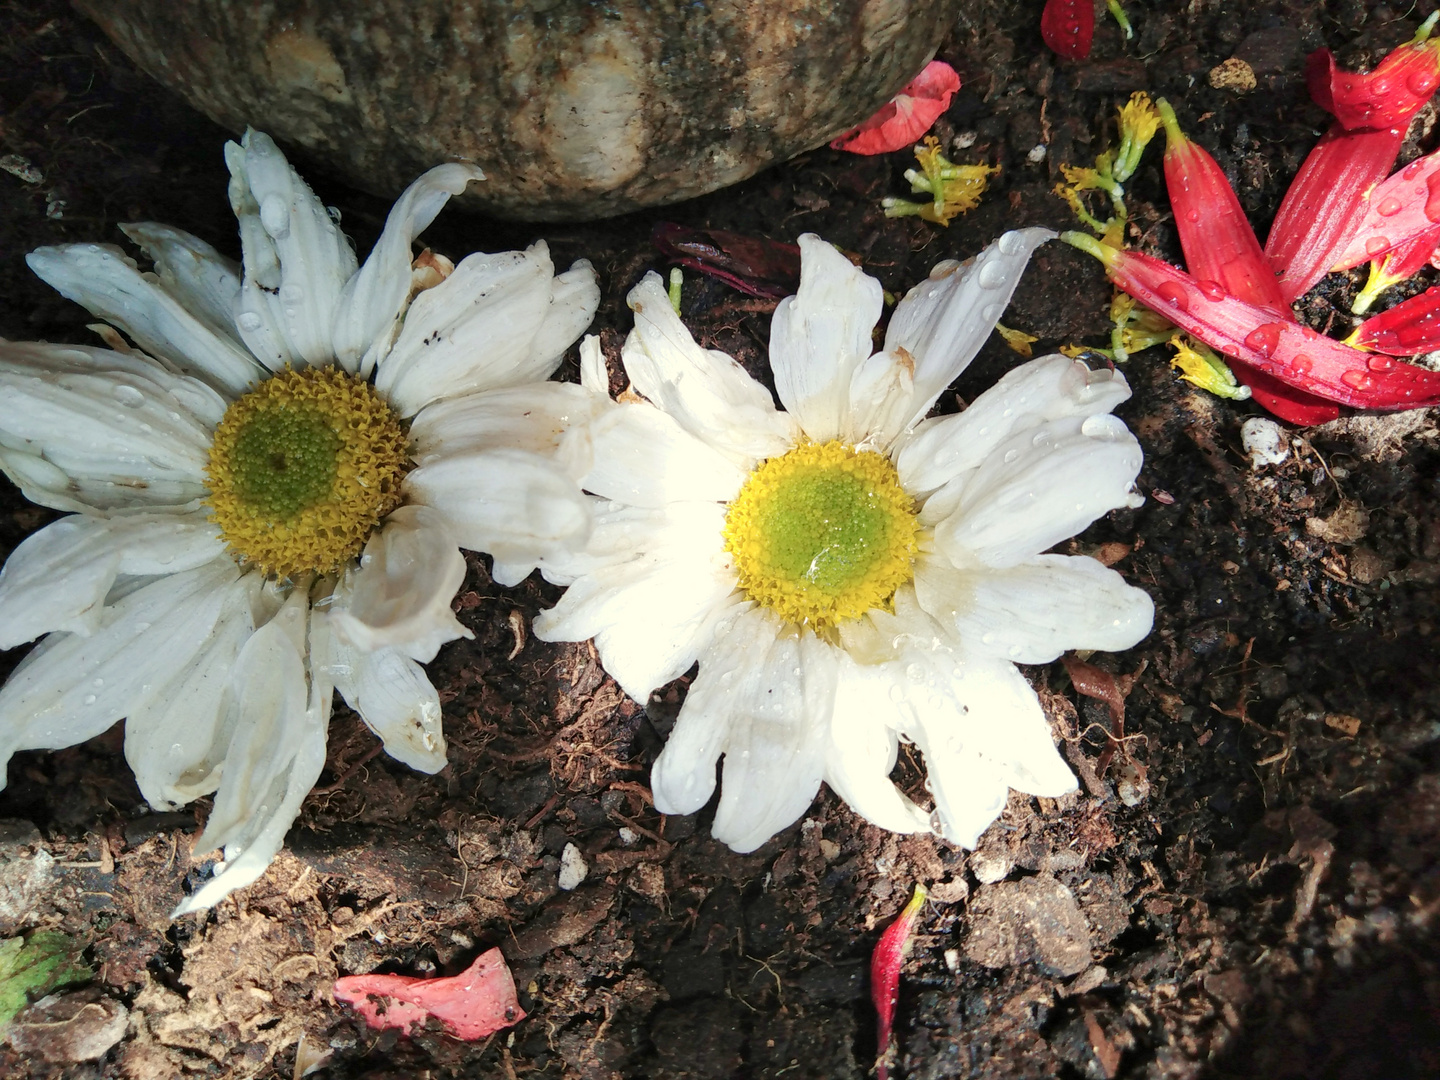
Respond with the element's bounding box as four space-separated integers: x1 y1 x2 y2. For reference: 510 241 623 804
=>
206 367 409 577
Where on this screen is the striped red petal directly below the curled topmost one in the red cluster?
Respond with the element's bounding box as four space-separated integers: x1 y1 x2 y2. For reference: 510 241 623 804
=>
1264 124 1405 304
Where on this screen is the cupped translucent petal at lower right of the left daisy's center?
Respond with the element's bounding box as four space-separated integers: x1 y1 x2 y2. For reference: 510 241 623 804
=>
330 505 475 662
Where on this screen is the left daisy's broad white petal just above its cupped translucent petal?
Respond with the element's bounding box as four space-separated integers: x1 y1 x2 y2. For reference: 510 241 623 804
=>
405 449 590 578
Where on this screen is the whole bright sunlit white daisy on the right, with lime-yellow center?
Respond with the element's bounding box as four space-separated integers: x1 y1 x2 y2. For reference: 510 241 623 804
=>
536 229 1153 851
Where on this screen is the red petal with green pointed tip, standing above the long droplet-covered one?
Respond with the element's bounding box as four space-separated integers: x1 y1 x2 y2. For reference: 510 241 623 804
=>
1165 107 1293 318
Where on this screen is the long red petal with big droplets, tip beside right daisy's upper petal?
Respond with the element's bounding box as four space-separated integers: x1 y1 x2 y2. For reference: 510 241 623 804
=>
1081 243 1440 410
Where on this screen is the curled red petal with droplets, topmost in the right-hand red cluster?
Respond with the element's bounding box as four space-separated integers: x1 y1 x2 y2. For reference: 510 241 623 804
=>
1305 40 1440 131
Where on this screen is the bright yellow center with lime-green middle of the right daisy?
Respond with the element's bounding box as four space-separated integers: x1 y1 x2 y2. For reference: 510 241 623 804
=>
724 441 919 631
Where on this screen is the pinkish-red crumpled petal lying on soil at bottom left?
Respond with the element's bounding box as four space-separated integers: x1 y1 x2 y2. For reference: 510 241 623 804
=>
334 949 526 1041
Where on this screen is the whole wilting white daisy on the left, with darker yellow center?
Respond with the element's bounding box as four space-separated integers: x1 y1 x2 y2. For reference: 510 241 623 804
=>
0 131 599 914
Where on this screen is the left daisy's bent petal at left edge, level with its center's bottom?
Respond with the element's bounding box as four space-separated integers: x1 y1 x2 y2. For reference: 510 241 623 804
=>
0 510 225 649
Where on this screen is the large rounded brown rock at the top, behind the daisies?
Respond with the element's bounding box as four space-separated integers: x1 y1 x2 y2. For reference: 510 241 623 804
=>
75 0 962 220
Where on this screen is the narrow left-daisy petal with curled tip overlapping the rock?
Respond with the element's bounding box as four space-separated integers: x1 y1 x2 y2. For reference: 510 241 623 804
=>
333 161 485 377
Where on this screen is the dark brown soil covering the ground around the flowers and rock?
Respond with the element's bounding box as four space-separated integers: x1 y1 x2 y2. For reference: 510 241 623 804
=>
0 0 1440 1080
